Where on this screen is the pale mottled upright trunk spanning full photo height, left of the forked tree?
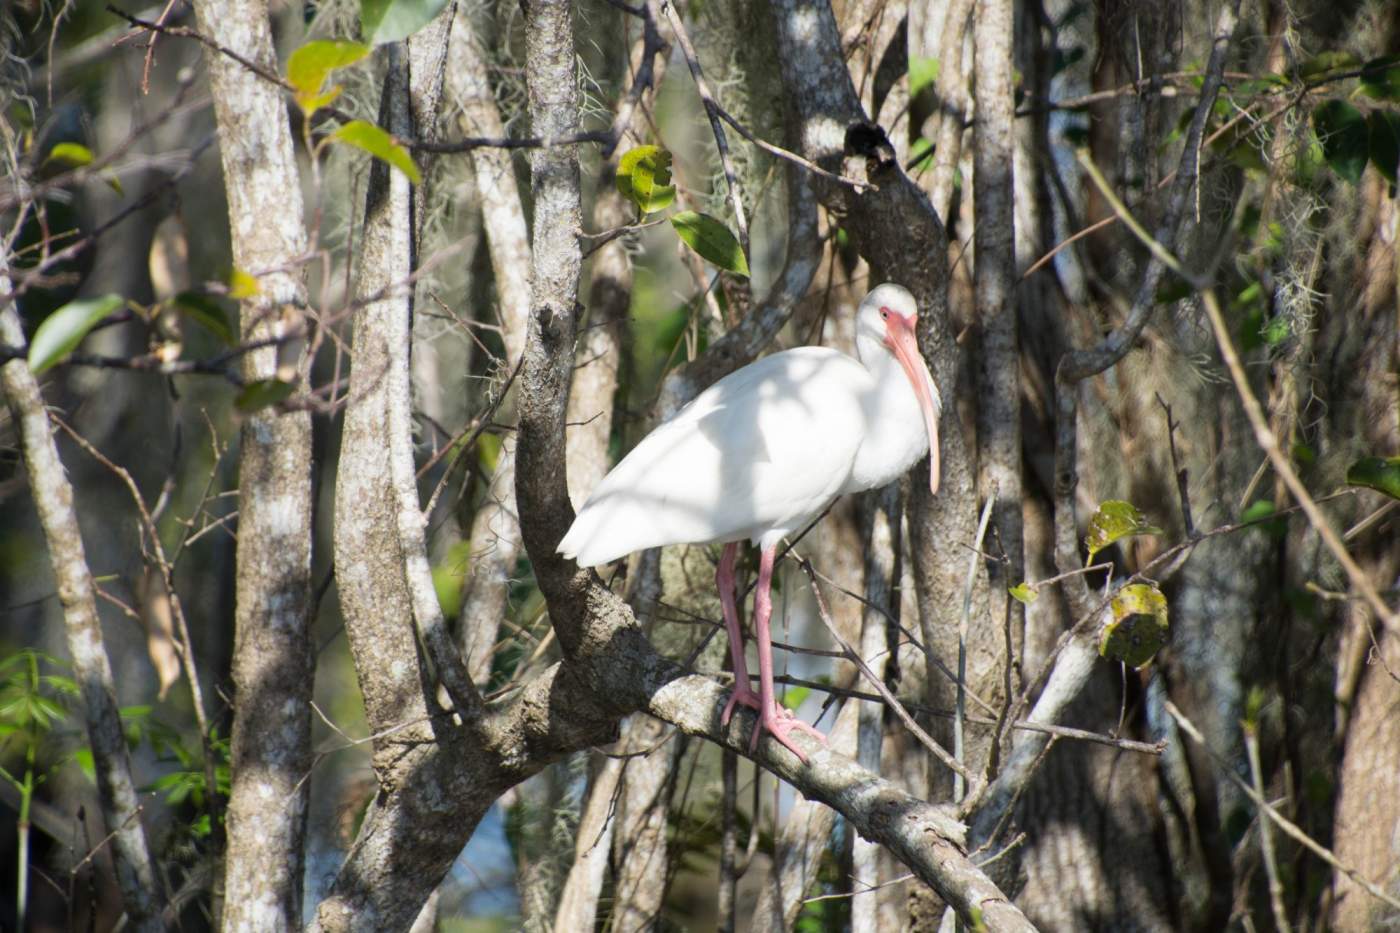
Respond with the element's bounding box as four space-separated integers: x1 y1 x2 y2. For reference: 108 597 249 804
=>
195 0 315 930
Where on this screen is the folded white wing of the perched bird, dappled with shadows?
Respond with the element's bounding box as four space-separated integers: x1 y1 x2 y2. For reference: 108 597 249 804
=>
560 347 869 566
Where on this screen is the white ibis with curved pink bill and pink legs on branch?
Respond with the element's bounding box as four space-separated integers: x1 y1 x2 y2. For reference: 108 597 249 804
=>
559 284 941 762
